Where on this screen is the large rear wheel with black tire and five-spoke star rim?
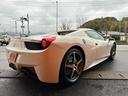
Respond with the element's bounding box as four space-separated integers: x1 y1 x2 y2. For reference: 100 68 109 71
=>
60 48 85 86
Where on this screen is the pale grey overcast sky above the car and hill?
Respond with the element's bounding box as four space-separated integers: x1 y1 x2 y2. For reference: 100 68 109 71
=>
0 0 128 33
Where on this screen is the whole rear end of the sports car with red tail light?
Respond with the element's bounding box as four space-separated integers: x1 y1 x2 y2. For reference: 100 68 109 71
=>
6 36 63 83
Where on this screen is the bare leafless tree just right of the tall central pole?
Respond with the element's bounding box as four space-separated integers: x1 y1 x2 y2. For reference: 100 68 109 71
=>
59 20 73 30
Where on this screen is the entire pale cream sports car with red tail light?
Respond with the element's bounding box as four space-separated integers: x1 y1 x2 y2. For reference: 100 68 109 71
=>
6 28 116 84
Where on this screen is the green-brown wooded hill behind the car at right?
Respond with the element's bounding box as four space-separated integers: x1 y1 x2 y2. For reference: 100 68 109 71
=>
80 17 128 32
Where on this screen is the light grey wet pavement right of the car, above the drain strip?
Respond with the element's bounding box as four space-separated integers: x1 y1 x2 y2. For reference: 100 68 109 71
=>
85 50 128 72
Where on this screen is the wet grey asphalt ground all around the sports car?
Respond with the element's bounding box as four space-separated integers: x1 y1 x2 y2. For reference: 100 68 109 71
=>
0 48 128 96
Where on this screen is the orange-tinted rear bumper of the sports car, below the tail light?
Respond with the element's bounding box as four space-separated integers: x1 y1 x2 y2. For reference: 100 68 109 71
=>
7 47 63 83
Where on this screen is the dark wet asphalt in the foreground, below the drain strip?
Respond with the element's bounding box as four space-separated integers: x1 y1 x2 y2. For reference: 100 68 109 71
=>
0 78 128 96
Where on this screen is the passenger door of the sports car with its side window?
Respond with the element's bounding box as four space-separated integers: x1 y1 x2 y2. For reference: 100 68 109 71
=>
86 30 108 60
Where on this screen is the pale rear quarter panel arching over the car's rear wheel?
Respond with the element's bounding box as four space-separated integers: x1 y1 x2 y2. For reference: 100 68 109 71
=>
54 36 95 69
